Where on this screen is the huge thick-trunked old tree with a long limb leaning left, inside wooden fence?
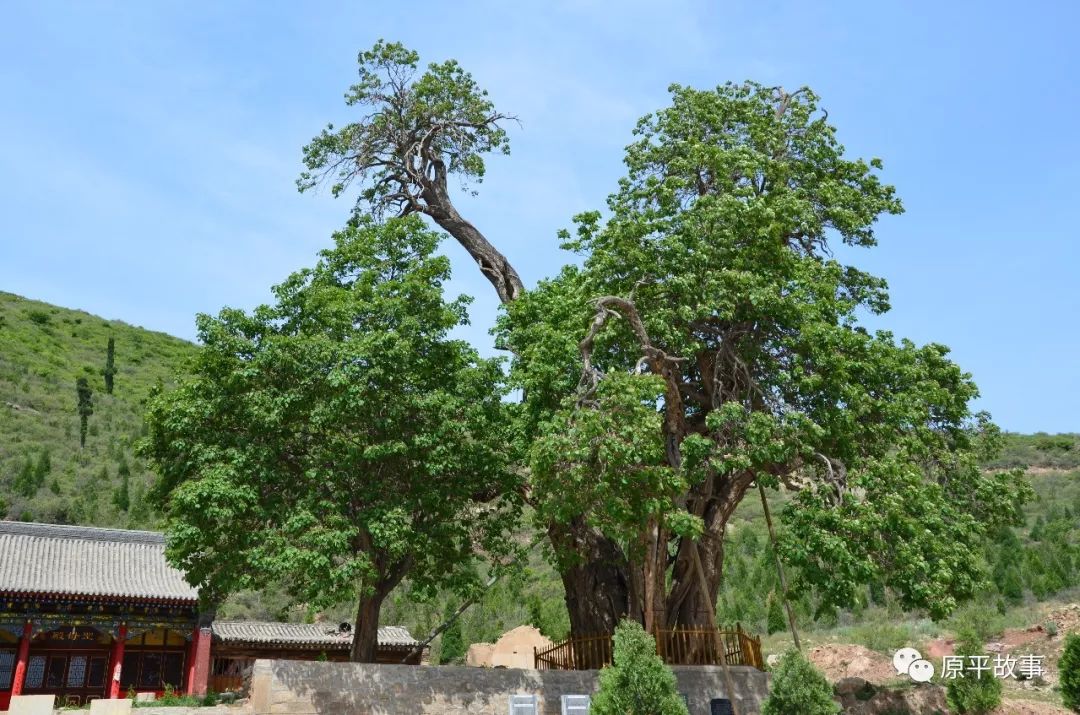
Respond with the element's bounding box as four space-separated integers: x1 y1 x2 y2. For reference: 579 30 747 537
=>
299 43 1027 633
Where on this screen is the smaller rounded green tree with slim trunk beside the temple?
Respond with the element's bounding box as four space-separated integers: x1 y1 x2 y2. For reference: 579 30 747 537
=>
144 217 518 661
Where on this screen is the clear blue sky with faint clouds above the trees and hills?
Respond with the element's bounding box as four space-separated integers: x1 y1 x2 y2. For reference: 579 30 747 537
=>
0 0 1080 431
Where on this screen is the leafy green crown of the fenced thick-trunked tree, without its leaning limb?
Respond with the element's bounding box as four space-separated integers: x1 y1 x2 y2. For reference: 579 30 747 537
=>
499 83 1030 618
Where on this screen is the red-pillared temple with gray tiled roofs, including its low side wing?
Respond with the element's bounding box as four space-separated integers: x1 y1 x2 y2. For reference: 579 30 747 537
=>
0 521 421 711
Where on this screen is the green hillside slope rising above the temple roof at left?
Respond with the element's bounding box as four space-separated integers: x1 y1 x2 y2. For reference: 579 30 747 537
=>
0 292 197 528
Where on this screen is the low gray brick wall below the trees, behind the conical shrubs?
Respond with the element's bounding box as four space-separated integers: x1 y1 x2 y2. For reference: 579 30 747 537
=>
249 660 768 715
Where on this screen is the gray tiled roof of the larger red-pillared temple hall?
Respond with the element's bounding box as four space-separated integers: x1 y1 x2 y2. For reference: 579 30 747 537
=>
0 521 199 602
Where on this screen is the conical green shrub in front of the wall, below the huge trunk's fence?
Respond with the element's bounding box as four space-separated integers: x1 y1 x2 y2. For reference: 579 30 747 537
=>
589 620 687 715
